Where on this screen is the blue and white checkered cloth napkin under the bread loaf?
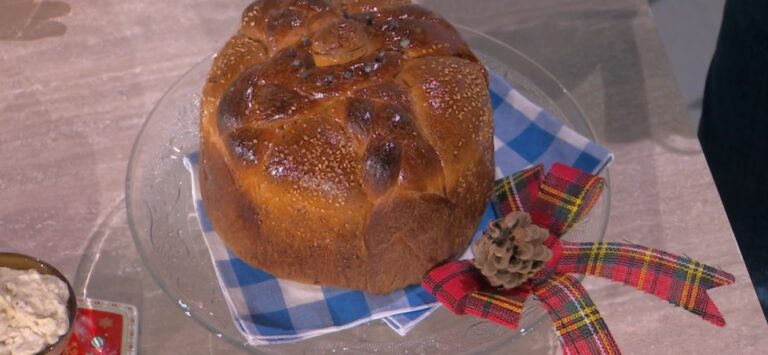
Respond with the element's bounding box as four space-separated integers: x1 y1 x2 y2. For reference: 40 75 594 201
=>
184 73 613 344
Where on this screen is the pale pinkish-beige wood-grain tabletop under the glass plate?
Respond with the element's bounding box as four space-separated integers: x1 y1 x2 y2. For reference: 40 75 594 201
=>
0 0 768 354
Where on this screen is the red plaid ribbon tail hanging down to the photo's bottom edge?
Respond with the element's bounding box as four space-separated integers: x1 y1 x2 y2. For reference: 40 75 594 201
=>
533 274 621 354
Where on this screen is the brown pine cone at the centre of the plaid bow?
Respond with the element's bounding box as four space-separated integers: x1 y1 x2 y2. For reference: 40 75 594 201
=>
472 212 552 289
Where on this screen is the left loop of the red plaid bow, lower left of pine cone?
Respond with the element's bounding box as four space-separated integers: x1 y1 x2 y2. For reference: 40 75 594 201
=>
421 260 529 329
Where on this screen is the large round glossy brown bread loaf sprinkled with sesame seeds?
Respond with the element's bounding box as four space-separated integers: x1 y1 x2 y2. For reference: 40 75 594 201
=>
200 0 494 293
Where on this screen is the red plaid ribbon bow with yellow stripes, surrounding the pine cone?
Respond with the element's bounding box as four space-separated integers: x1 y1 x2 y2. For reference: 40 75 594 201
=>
422 164 734 354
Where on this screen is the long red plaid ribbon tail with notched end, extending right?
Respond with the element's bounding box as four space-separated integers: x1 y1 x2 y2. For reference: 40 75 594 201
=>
556 242 735 327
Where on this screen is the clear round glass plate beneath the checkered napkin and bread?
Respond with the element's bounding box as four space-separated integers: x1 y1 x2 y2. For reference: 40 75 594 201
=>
126 26 610 353
